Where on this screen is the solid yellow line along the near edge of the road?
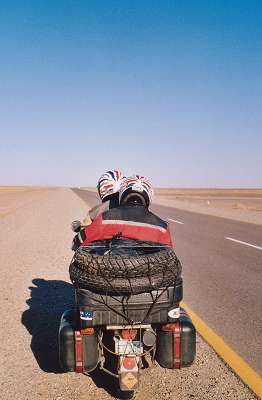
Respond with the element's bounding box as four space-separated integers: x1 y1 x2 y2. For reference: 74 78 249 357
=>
181 302 262 399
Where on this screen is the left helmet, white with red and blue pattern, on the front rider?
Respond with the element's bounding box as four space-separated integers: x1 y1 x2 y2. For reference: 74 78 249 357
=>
97 169 123 201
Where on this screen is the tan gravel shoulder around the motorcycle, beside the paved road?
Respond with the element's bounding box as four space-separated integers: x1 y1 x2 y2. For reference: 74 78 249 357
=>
0 189 256 400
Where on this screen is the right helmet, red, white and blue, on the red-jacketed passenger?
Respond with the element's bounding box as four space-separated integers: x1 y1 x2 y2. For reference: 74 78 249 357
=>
119 175 154 207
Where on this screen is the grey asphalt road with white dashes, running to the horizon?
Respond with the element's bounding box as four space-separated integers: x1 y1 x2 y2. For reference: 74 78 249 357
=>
74 189 262 374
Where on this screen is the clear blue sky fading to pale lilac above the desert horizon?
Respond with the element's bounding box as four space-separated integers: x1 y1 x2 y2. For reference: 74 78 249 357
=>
0 0 262 187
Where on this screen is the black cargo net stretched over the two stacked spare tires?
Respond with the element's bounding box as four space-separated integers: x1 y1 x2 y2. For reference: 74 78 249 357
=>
69 237 181 324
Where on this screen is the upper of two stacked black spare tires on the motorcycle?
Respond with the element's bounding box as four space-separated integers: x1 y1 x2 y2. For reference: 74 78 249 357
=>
72 247 181 278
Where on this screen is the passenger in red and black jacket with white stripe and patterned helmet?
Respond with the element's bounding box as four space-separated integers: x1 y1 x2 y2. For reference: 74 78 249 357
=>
81 175 172 247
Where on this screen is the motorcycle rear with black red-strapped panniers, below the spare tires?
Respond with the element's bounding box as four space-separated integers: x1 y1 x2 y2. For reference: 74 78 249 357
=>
59 231 196 398
